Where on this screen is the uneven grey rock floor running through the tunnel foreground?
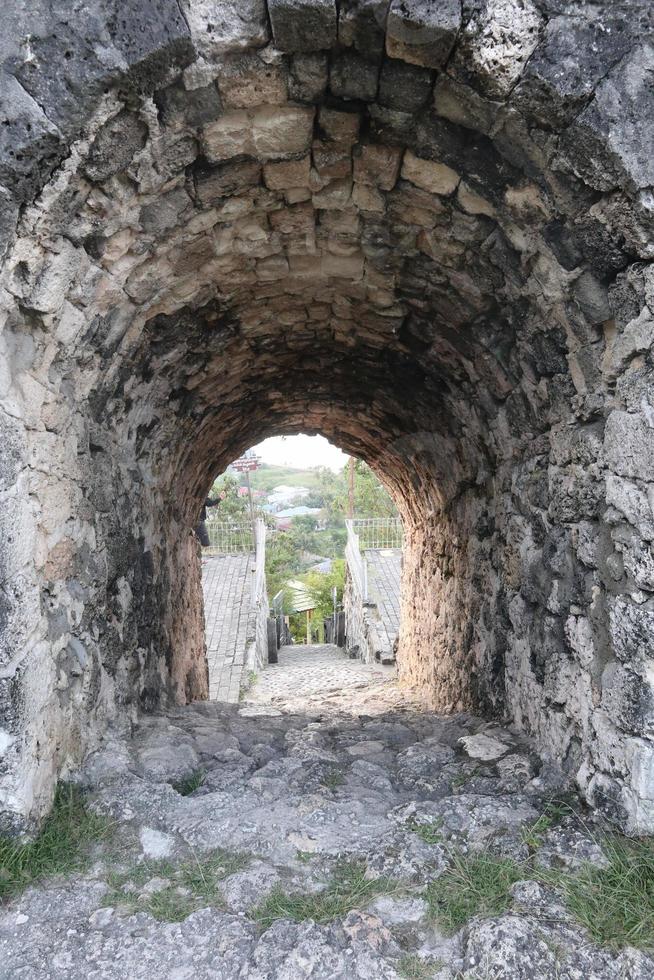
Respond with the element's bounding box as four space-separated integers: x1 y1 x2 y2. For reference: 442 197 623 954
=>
0 664 654 980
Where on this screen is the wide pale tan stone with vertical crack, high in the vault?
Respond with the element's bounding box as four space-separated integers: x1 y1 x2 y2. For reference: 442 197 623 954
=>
202 106 314 162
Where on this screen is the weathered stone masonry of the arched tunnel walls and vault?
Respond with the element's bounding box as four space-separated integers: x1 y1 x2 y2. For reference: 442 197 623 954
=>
0 0 654 831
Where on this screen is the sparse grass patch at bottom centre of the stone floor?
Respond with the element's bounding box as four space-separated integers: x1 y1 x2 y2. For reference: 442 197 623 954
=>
252 861 401 929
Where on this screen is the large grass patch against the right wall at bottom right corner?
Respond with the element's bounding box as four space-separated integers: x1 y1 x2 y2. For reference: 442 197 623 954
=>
538 835 654 952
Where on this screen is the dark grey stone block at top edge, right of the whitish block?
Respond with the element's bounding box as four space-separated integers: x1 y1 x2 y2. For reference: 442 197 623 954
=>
268 0 336 52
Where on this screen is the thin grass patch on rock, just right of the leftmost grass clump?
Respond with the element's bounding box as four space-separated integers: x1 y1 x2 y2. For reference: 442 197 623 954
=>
103 848 250 922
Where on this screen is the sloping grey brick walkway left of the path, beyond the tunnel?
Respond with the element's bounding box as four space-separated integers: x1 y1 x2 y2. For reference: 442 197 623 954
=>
202 554 254 704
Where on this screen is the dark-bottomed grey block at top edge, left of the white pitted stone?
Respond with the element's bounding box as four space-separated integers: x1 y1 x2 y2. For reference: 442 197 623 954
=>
386 0 461 68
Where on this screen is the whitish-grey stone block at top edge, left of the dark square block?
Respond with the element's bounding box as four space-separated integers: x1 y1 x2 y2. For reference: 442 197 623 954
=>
180 0 270 61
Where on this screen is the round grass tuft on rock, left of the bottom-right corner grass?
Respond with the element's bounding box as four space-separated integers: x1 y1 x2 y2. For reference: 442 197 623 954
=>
425 853 532 932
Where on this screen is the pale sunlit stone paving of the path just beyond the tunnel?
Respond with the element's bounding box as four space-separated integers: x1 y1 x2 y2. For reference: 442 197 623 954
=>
245 643 395 708
